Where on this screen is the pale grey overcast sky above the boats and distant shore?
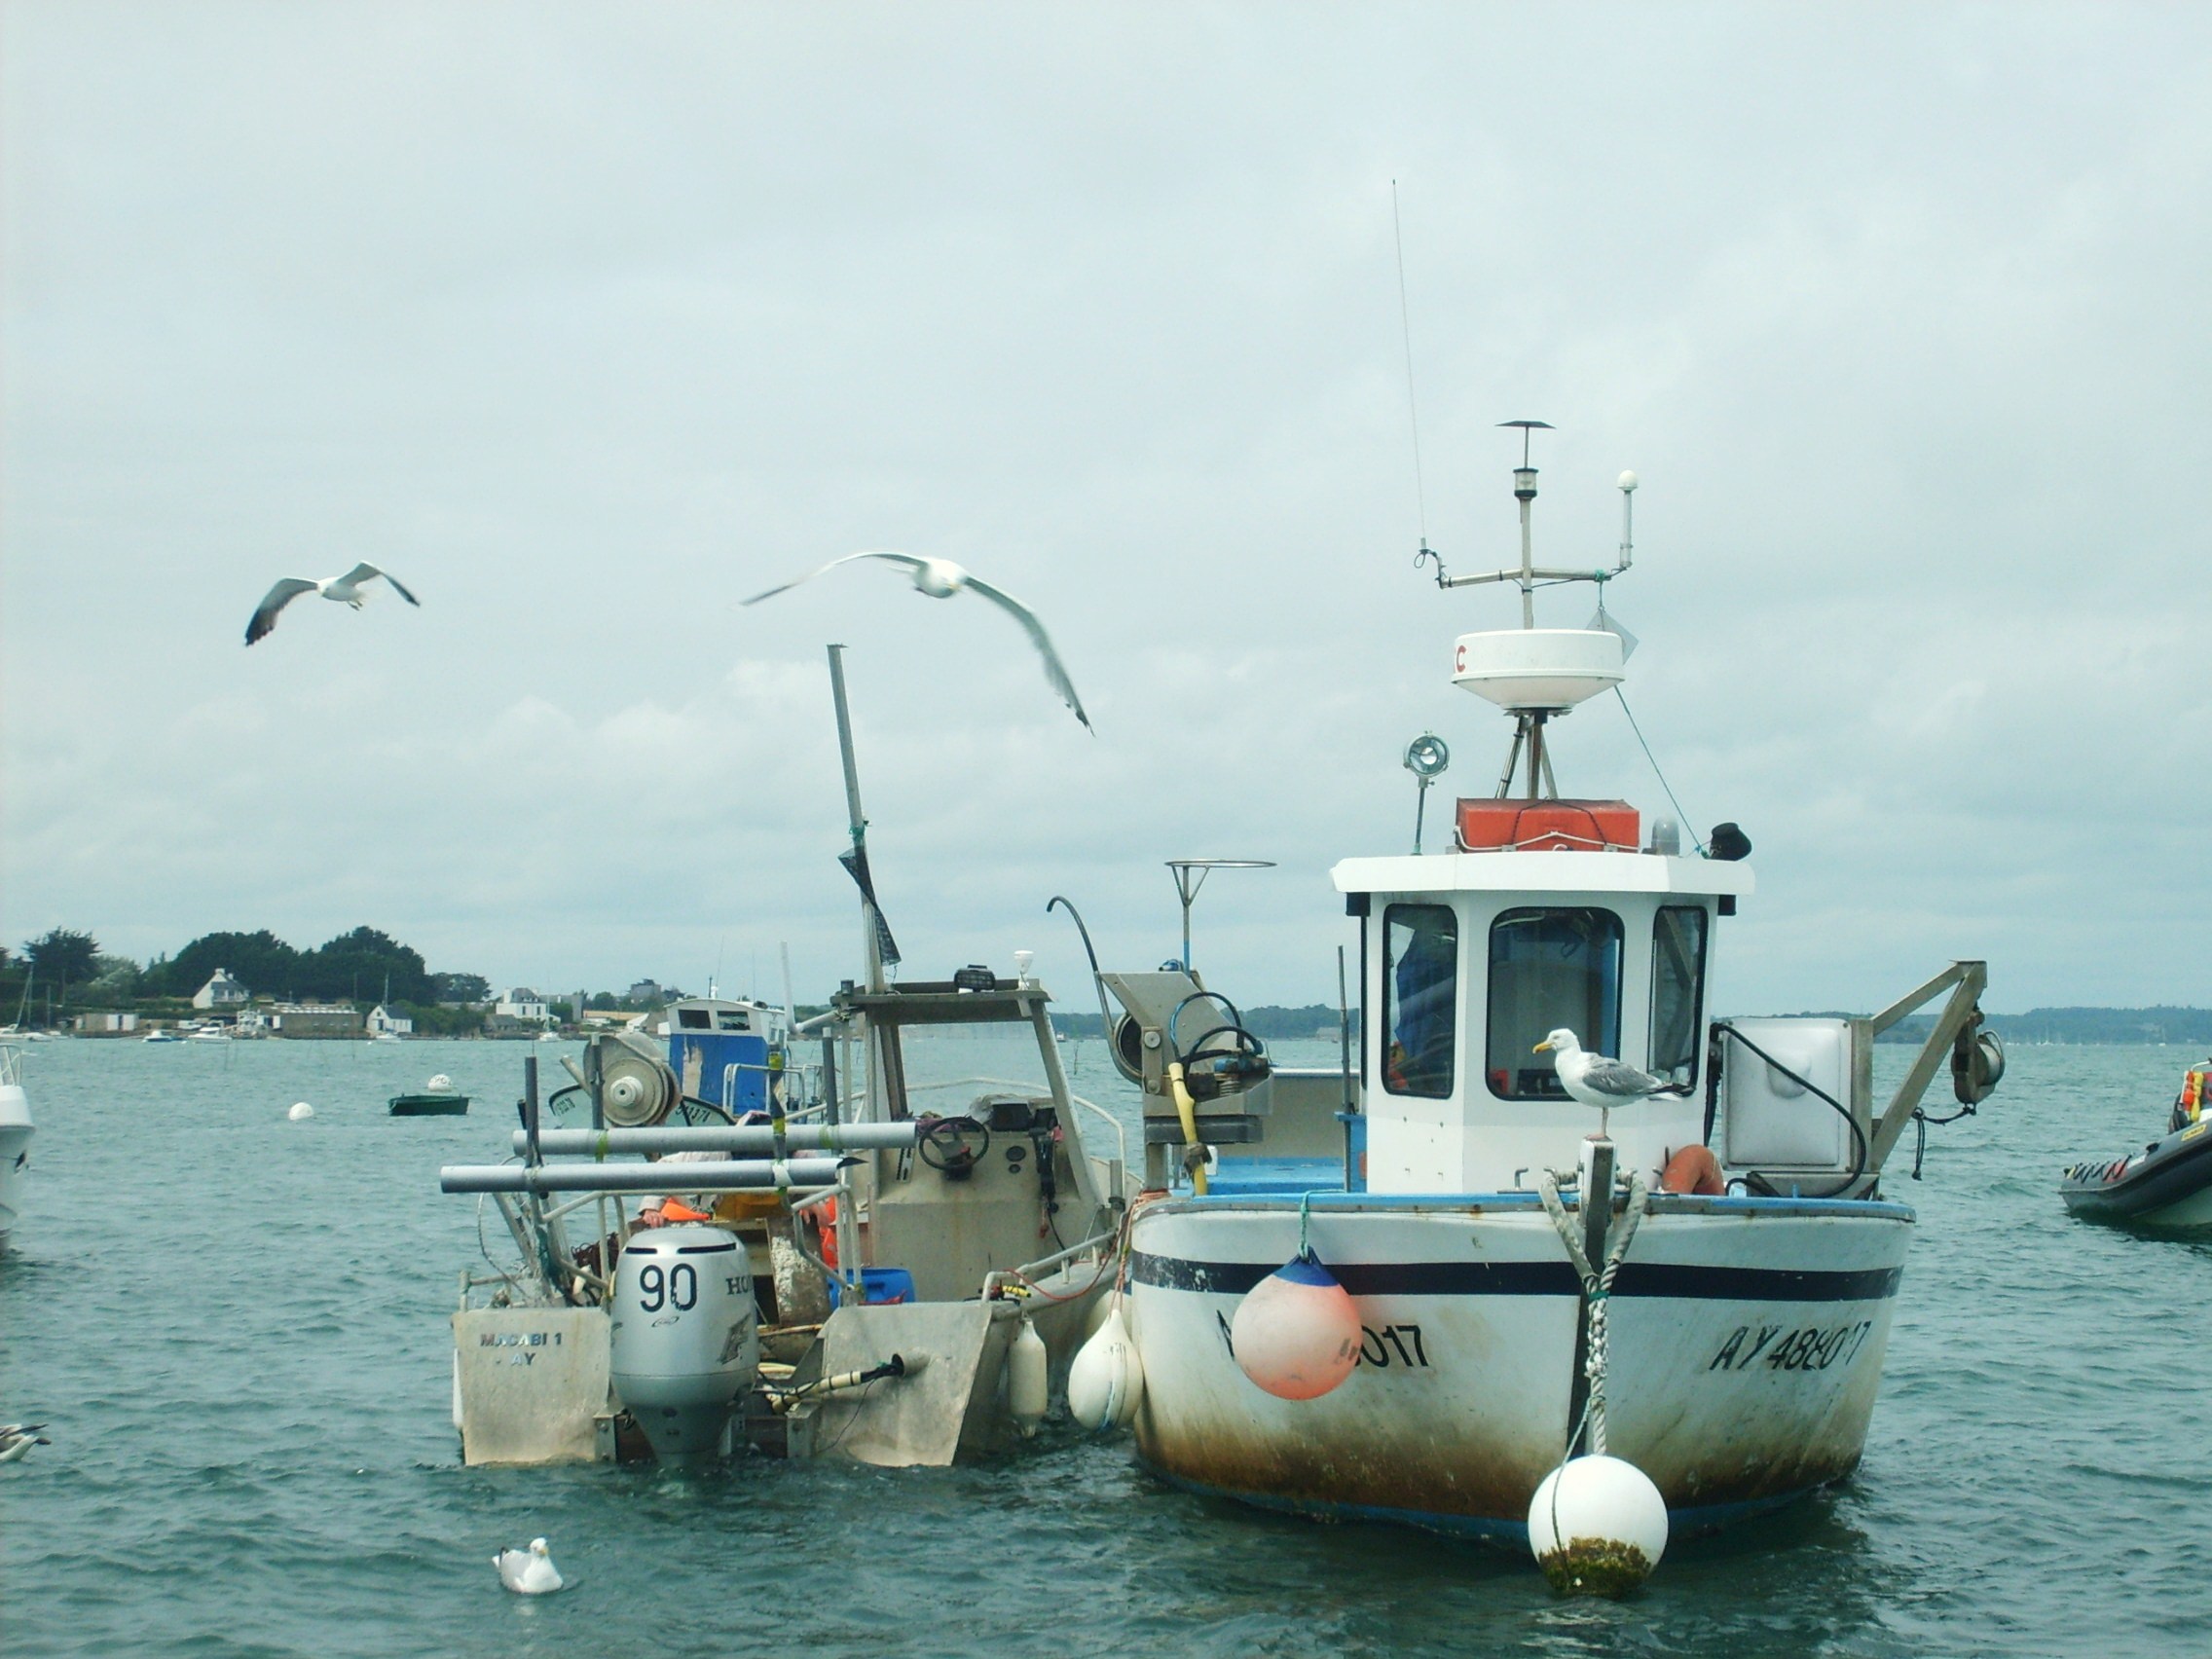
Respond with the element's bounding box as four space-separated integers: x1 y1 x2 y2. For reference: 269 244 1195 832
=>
0 0 2212 1011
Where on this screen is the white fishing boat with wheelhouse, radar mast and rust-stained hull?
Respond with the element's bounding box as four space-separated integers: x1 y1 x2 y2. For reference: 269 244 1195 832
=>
1080 423 2002 1586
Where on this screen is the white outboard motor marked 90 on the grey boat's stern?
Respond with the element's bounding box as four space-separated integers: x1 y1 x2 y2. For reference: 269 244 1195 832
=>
612 1226 761 1466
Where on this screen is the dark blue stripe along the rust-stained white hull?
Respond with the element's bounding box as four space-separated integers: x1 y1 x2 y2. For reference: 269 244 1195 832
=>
1128 1250 1904 1303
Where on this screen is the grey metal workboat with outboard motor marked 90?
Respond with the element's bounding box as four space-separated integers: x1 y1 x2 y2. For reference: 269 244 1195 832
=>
440 645 1125 1466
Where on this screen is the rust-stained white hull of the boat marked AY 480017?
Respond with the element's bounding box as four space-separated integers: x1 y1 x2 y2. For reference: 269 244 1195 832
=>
1130 1195 1911 1537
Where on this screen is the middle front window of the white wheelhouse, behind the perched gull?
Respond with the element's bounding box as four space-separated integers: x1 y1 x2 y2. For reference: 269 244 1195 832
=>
1487 907 1621 1099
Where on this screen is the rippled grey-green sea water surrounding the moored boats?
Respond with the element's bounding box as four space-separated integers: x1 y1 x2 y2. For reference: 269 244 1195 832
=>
0 1038 2212 1659
